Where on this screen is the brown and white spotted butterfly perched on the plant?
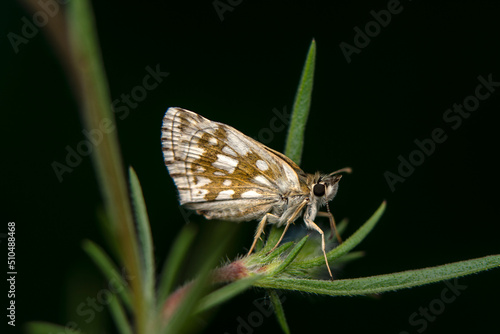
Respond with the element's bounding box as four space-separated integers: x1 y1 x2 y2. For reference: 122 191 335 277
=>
161 108 351 278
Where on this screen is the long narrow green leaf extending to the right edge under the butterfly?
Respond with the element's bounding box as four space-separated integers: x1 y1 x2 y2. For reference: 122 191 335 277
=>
255 255 500 296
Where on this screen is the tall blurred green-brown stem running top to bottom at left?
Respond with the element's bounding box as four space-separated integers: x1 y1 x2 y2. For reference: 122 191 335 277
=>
68 0 147 334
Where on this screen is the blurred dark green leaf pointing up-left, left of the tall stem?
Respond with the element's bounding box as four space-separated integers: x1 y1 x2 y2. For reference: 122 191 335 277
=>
82 240 135 311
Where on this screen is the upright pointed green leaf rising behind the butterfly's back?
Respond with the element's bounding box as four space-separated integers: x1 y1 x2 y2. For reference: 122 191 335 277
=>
285 39 316 166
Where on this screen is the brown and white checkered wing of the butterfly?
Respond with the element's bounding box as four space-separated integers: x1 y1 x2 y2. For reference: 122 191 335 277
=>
162 108 303 220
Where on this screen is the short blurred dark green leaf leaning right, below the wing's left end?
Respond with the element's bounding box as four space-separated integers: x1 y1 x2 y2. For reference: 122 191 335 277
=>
157 225 196 305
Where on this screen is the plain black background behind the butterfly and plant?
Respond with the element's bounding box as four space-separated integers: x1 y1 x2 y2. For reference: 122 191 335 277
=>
0 0 500 333
